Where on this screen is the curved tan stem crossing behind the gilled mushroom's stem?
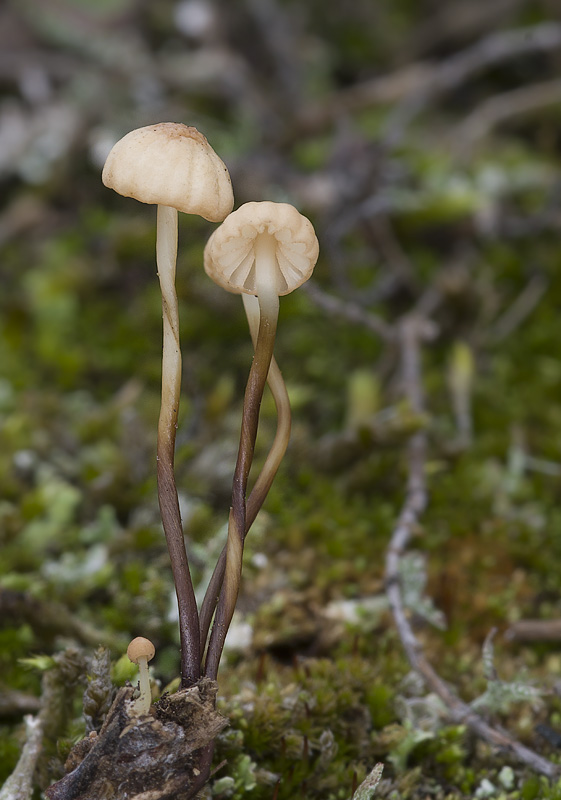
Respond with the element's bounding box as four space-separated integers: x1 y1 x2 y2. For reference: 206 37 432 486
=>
200 294 292 655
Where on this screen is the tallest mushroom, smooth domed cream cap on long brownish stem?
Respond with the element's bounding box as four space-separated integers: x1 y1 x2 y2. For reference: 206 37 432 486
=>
102 122 234 687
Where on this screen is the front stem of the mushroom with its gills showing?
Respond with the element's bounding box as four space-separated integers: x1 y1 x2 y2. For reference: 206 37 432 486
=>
205 234 279 680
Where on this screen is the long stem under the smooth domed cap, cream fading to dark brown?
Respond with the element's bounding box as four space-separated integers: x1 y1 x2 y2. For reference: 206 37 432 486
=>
156 205 200 688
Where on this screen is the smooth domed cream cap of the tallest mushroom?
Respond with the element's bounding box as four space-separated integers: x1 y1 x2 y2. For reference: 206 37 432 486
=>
102 122 234 222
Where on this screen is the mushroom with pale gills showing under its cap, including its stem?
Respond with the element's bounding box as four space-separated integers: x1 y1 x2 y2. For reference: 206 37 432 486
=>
201 201 319 679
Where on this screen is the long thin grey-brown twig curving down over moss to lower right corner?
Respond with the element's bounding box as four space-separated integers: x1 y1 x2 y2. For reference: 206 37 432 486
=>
385 317 560 779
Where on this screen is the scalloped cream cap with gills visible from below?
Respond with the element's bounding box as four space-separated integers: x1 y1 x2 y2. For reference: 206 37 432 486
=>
205 200 319 295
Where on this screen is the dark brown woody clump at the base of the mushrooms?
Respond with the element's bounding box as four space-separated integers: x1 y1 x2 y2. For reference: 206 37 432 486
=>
46 678 228 800
